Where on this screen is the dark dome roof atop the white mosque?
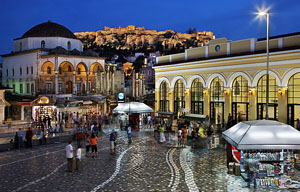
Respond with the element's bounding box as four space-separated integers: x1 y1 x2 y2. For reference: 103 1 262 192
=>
21 21 77 39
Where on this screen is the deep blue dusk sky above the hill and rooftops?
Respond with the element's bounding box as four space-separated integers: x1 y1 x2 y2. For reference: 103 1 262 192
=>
0 0 300 57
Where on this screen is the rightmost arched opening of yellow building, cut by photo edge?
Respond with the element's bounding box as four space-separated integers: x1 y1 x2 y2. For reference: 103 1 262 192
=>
287 73 300 127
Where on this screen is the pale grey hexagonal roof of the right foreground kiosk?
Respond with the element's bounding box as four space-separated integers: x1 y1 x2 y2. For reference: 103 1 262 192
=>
222 120 300 150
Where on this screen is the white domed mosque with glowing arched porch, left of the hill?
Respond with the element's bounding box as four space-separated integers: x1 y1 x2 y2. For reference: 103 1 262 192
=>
2 21 121 122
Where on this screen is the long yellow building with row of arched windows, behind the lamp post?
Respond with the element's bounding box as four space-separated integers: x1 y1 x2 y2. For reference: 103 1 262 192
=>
154 33 300 126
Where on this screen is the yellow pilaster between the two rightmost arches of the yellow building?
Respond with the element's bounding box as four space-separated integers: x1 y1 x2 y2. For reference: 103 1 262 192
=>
278 88 288 123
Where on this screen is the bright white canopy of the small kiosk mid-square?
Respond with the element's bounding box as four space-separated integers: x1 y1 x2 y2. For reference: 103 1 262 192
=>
113 102 153 113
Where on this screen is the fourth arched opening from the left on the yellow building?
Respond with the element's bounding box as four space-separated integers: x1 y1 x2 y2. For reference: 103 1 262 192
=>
210 77 224 125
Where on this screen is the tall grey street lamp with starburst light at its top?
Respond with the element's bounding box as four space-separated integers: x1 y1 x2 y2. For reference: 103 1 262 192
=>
258 10 270 120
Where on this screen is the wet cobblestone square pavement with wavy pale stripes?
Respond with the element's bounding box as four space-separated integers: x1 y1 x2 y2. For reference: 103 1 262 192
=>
0 130 298 192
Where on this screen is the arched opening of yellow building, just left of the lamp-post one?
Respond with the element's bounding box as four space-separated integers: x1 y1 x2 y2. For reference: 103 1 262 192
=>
231 76 249 123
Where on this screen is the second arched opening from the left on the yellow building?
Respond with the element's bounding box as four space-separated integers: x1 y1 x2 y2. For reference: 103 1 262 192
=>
174 80 185 115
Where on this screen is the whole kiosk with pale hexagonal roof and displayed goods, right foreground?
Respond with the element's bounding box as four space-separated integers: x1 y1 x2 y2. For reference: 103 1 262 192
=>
222 120 300 189
